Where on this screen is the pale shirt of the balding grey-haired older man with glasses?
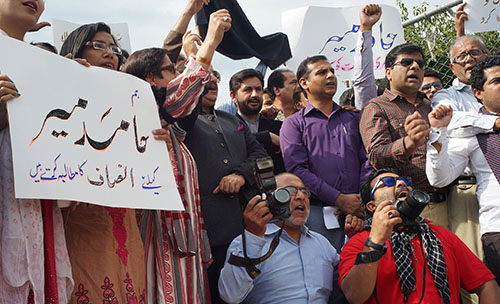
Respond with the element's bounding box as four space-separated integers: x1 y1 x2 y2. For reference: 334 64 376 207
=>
432 78 498 137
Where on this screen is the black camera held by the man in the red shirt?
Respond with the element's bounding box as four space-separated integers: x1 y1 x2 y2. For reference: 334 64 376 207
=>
394 189 430 232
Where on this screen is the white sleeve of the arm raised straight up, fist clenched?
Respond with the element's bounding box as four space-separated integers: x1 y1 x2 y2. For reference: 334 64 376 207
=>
353 31 377 109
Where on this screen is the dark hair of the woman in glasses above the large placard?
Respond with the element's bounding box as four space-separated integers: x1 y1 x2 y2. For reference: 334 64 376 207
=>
59 22 123 70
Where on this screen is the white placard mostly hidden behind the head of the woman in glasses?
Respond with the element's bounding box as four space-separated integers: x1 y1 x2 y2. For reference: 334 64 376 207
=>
51 19 132 54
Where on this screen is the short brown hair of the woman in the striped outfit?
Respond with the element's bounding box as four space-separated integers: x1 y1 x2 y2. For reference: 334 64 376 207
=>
122 48 168 80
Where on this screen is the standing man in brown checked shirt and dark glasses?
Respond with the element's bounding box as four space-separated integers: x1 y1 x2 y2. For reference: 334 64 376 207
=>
360 44 448 228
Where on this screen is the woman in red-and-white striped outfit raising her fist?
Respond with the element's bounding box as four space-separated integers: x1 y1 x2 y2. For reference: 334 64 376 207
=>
123 8 228 303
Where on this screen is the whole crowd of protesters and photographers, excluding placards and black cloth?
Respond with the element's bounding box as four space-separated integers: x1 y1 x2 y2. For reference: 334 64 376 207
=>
0 0 500 304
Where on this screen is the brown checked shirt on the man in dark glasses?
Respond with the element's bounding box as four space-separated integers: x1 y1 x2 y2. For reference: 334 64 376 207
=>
359 90 433 191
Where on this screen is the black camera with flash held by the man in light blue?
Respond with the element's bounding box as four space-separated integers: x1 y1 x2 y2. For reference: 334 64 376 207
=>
254 157 291 223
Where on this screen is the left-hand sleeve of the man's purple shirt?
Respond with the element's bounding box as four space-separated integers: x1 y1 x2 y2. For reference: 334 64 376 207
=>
280 115 340 205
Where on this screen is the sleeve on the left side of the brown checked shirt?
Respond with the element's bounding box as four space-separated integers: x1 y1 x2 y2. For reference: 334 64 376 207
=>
359 102 410 170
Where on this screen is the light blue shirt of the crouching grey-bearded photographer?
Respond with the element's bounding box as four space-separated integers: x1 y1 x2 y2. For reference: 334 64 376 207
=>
219 224 339 304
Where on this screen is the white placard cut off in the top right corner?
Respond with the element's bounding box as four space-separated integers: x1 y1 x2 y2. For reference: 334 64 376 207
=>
464 0 500 34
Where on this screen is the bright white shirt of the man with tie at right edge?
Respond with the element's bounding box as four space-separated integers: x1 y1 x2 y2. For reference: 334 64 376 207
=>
426 126 500 235
